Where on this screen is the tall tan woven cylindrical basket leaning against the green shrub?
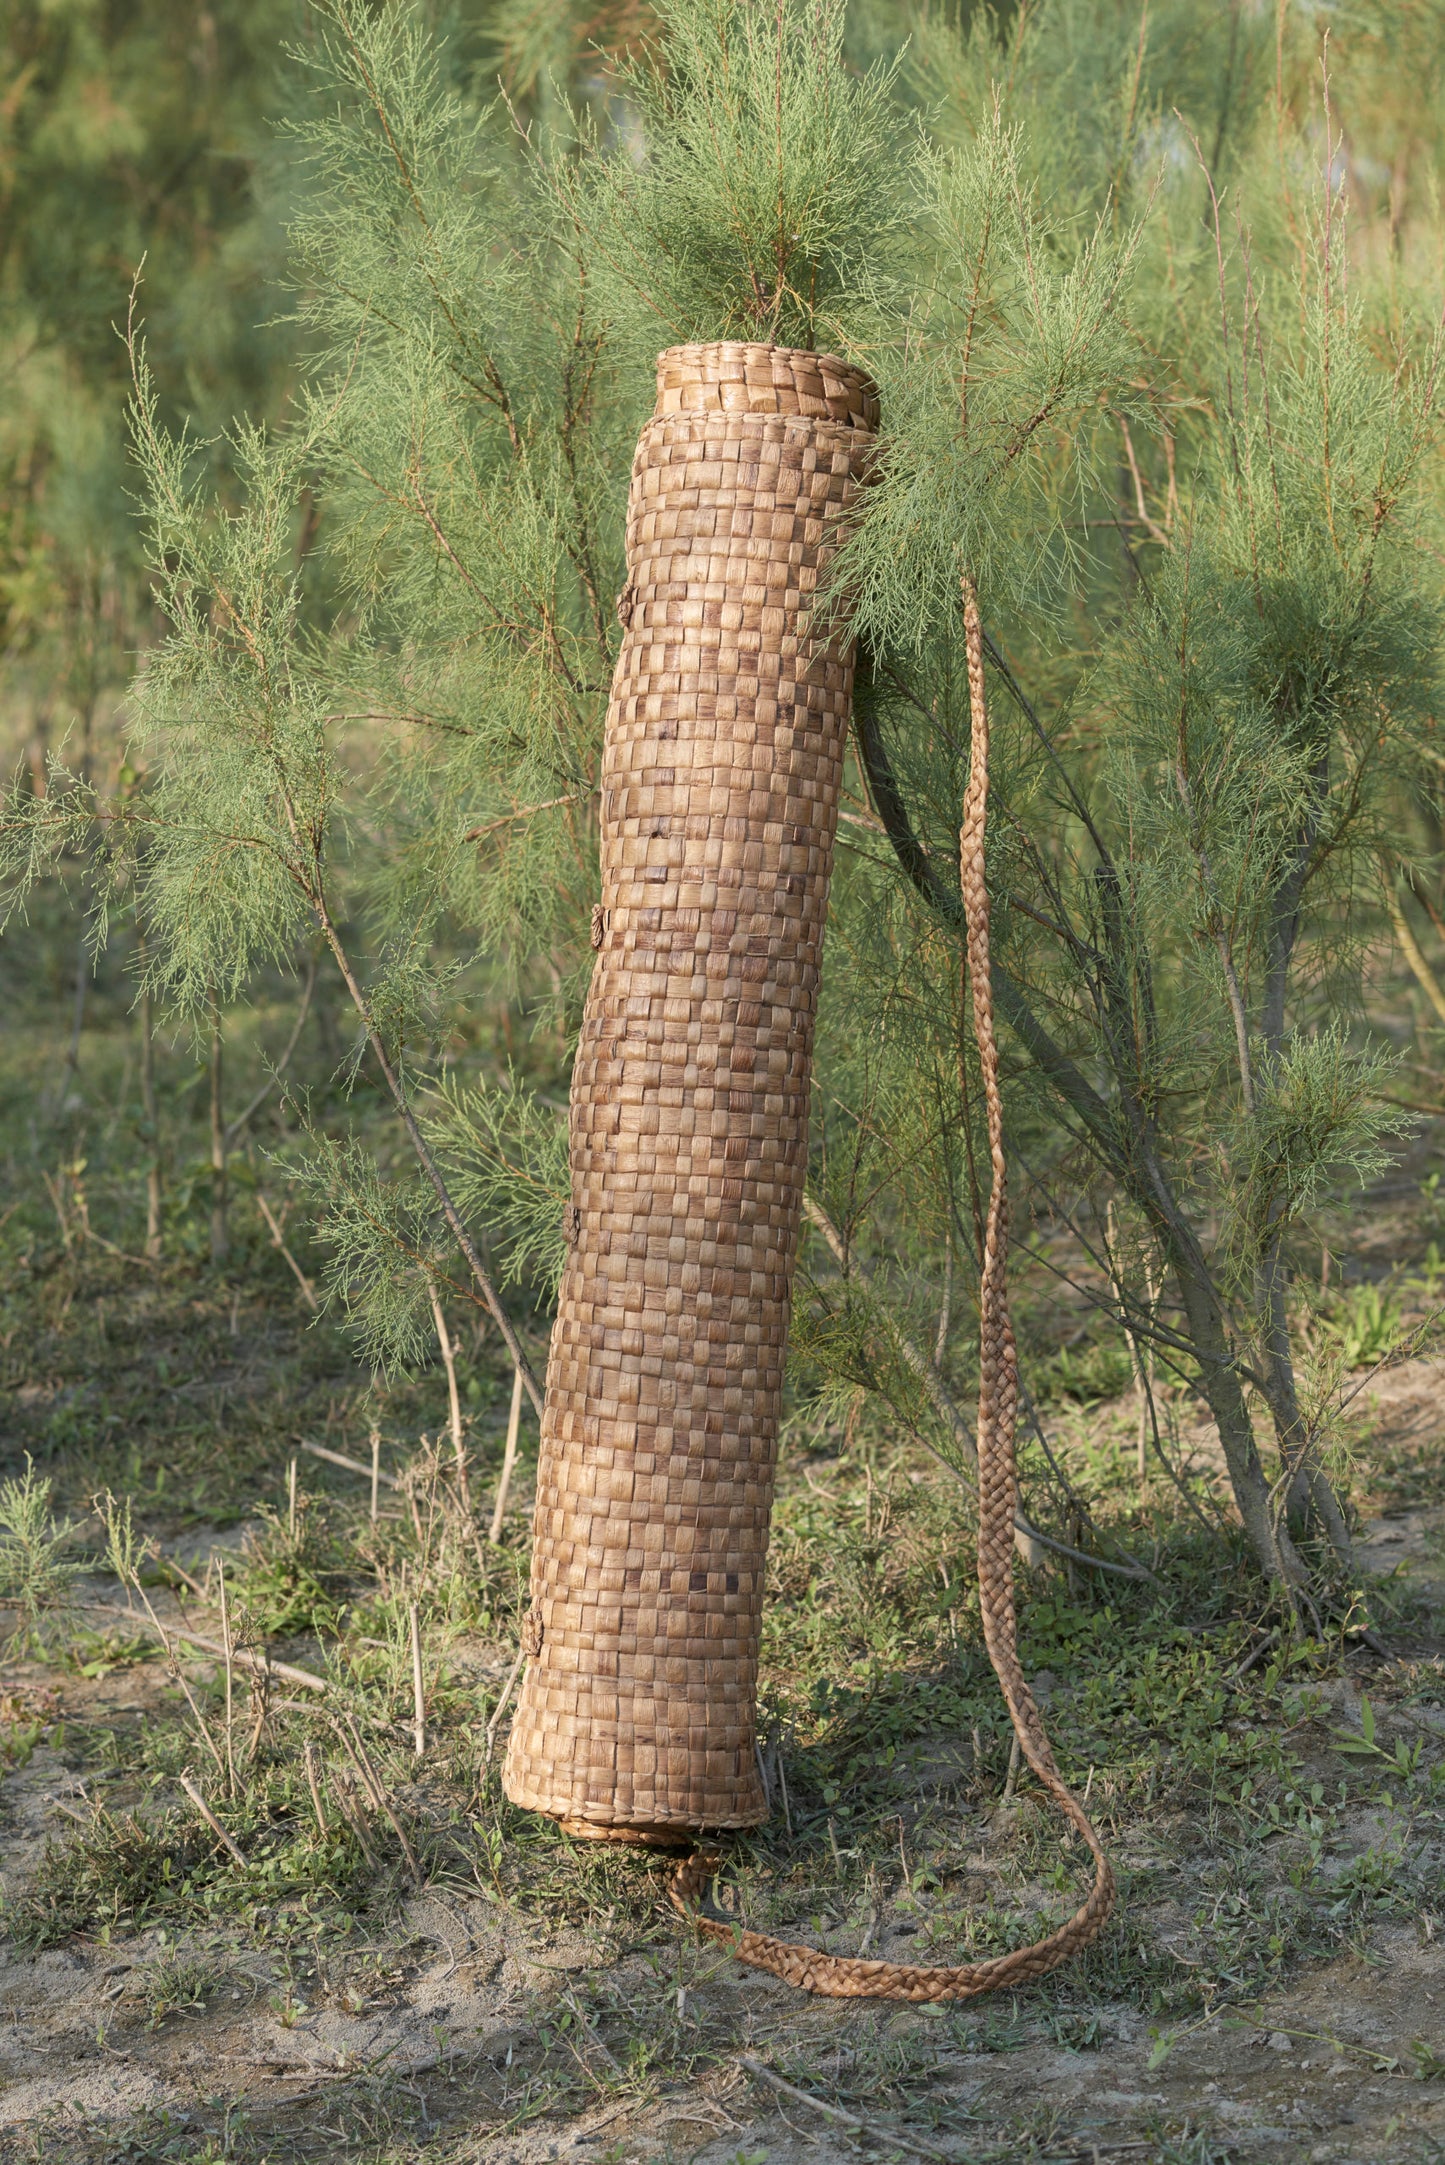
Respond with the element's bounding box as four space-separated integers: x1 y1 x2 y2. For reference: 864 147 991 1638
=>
505 344 877 1840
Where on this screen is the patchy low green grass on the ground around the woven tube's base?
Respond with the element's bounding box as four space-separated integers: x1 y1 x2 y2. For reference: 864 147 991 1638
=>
0 917 1445 2165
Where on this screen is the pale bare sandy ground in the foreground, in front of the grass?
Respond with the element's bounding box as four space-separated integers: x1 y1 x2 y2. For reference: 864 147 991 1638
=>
0 1362 1445 2165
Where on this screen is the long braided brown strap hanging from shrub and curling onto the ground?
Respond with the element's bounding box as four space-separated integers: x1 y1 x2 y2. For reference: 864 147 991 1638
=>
667 576 1114 2000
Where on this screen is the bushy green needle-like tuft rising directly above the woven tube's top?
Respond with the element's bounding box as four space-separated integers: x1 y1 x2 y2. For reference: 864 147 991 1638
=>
552 0 916 353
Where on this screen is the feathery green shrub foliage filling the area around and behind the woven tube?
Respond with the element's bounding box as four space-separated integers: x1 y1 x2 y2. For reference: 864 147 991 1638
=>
0 0 1443 1610
